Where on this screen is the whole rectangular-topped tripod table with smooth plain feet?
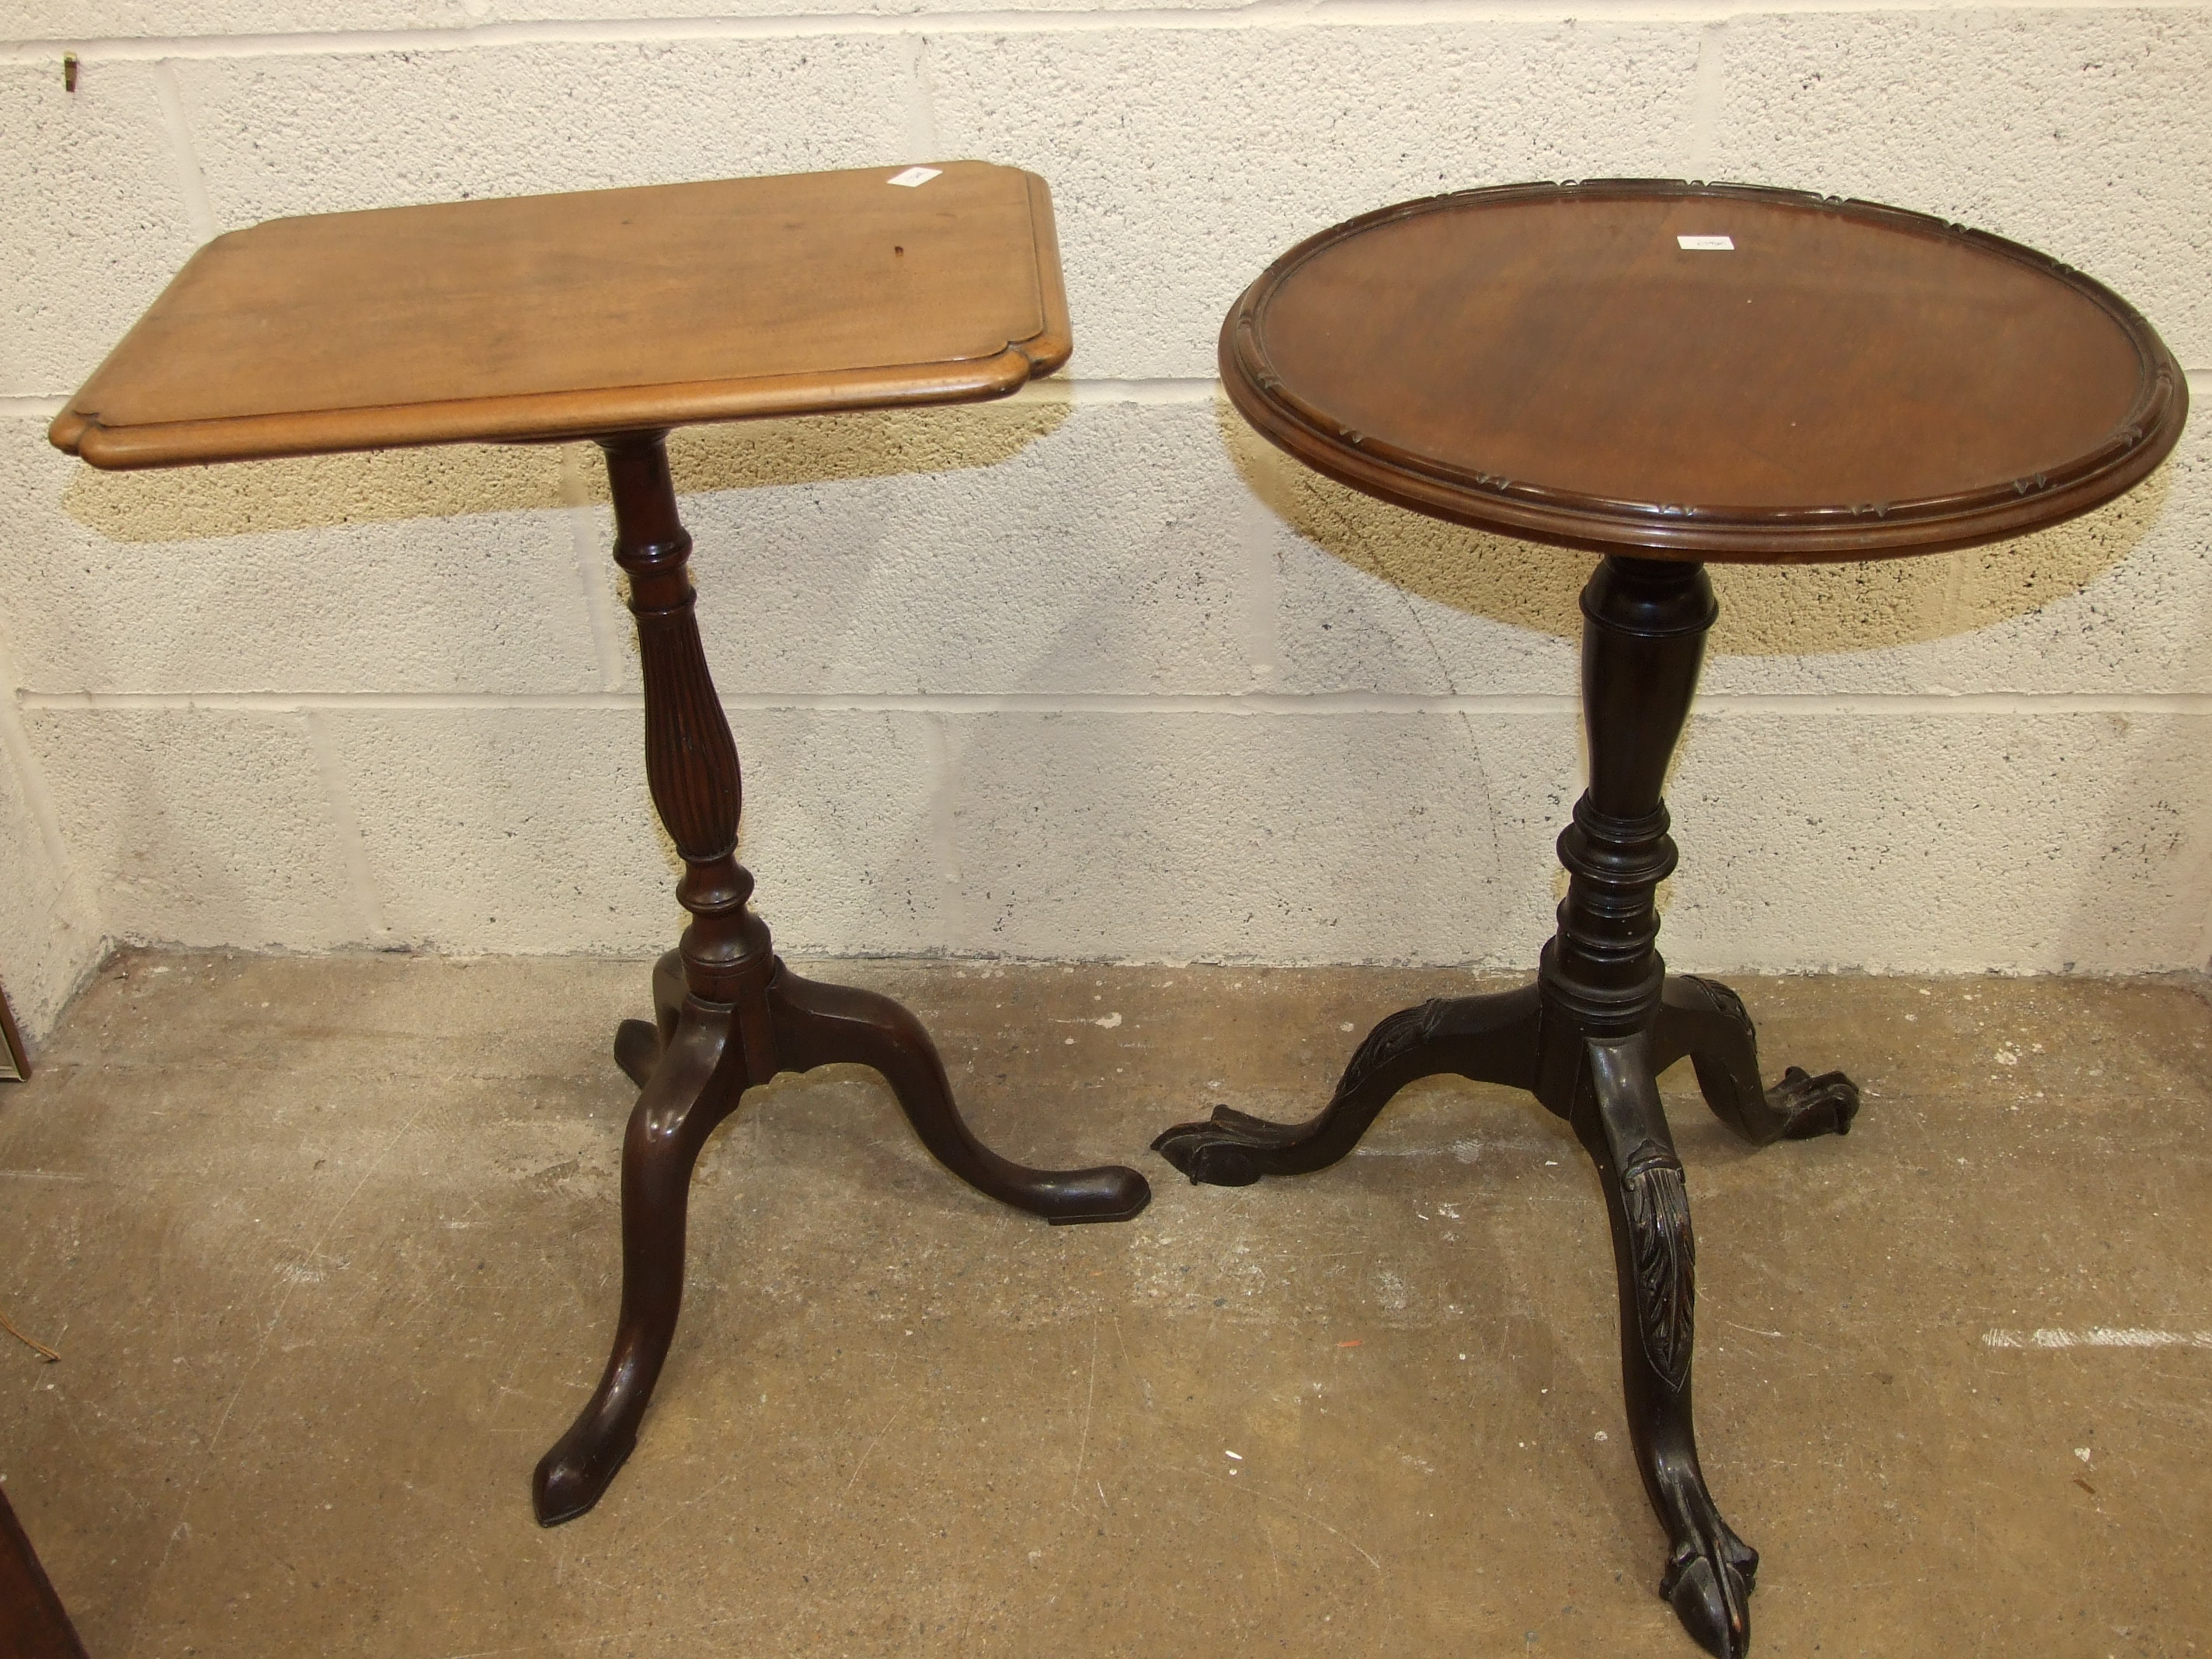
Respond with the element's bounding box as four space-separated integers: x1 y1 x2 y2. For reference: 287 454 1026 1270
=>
51 162 1150 1526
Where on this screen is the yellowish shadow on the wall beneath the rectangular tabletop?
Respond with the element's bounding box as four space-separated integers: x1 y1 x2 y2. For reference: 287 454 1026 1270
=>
62 396 1069 542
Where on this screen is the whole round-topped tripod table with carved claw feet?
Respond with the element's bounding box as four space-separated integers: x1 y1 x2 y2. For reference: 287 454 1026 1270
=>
1155 179 2188 1659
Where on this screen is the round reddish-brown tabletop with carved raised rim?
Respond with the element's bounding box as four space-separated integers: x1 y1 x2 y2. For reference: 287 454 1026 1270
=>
1221 179 2188 562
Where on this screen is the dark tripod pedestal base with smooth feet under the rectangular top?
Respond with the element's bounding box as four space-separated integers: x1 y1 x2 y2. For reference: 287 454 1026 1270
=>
531 431 1153 1526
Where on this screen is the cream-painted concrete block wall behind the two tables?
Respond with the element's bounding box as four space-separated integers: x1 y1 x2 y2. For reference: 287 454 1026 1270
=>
0 0 2212 1031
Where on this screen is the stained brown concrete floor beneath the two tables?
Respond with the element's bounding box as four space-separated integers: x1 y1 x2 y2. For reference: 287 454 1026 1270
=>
0 953 2212 1659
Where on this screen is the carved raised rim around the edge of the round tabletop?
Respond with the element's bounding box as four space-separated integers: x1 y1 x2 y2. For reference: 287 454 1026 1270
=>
1219 179 2188 564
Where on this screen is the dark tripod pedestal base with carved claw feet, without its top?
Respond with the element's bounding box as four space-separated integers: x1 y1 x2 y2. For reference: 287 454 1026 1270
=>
1153 558 1858 1659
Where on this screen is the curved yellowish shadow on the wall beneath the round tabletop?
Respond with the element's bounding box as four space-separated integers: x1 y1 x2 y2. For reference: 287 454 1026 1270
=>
1215 398 2170 657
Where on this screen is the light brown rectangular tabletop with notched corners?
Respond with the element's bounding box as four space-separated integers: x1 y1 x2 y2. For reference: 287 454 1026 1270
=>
49 162 1070 467
